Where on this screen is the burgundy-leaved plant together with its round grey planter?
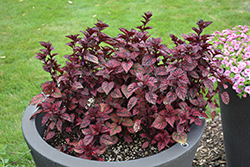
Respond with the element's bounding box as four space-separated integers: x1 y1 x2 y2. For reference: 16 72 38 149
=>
22 12 228 167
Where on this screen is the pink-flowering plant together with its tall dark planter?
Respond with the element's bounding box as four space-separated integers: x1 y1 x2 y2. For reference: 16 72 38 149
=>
211 25 250 167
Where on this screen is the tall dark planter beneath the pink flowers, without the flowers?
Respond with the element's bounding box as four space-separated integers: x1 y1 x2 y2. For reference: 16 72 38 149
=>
220 85 250 167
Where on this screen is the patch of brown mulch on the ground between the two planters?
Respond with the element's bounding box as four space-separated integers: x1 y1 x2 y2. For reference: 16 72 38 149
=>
192 115 226 167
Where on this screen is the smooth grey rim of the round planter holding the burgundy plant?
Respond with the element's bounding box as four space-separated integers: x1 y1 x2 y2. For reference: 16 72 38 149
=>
22 105 205 167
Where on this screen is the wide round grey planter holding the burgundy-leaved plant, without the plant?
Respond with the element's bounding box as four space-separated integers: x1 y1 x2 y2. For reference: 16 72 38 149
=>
22 106 205 167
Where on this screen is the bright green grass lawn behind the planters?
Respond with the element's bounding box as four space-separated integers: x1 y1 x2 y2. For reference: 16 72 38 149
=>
0 0 250 166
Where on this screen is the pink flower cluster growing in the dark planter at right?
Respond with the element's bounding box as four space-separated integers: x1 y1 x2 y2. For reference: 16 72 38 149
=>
211 25 250 97
